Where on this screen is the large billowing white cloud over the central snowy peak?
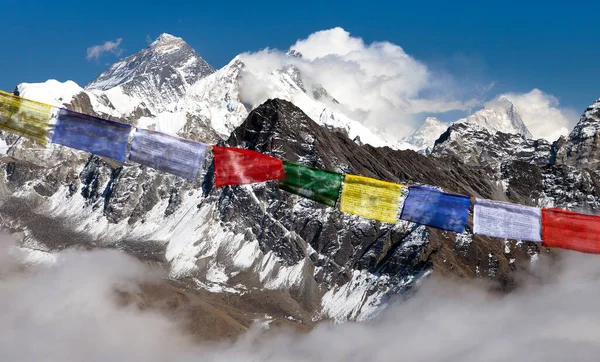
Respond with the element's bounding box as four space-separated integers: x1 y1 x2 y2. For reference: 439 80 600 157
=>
240 28 480 139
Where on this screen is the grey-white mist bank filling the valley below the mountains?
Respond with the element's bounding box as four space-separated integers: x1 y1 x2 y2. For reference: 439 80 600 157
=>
0 230 600 362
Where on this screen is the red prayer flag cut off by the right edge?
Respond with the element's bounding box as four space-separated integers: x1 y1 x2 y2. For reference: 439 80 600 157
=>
542 208 600 254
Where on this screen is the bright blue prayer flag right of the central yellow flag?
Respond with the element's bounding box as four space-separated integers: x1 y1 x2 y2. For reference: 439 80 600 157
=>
400 186 471 233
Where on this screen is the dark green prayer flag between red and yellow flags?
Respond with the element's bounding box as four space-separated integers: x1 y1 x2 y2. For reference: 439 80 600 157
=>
279 161 344 206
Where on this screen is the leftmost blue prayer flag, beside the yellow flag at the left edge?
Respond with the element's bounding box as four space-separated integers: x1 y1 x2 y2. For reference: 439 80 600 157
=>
52 109 131 163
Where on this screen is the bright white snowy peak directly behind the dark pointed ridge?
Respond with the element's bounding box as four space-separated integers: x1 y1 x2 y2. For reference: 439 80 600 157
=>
168 56 387 146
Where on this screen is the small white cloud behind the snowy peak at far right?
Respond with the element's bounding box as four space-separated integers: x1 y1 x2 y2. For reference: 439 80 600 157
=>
503 89 579 141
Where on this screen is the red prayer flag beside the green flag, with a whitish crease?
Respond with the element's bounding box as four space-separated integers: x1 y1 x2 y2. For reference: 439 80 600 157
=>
213 146 285 187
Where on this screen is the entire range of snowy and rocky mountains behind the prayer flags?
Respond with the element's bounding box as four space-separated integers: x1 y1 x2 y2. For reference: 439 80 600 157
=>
0 36 600 326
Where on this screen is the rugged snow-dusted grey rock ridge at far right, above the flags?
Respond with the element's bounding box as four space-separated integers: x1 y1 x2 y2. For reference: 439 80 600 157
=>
432 101 600 213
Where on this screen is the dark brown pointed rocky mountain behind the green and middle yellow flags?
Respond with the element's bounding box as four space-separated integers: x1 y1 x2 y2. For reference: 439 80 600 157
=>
220 100 537 292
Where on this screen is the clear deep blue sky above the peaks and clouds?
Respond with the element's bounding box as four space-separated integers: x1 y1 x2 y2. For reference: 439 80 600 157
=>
0 0 600 127
